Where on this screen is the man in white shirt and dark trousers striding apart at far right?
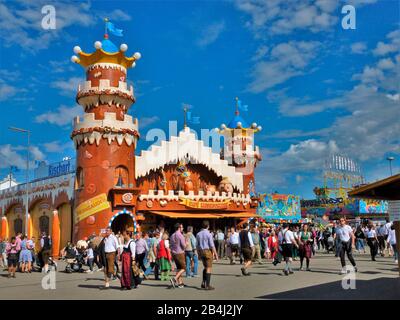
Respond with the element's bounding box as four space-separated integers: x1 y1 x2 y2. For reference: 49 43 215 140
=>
335 218 357 274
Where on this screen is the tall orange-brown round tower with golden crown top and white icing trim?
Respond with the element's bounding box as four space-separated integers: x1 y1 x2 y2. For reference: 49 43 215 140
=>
71 34 141 240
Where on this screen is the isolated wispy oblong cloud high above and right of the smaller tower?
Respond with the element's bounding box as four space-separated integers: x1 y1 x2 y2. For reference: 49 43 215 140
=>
248 41 320 93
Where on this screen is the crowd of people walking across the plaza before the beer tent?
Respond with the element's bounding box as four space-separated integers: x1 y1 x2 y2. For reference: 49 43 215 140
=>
0 218 398 290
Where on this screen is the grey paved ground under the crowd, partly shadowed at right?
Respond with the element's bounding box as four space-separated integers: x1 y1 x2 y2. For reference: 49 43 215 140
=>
0 254 400 300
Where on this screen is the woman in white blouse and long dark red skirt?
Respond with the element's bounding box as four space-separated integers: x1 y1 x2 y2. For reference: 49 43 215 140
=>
121 231 138 290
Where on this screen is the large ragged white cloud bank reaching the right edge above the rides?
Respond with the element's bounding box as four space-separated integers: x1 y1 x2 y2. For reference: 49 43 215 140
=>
258 27 400 190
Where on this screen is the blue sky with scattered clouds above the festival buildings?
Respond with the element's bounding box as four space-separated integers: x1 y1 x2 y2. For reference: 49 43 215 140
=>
0 0 400 198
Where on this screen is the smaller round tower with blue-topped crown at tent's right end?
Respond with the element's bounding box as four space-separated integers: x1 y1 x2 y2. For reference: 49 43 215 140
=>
215 97 262 196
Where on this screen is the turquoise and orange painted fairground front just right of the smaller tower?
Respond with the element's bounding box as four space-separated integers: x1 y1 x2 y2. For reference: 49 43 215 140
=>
257 193 301 221
